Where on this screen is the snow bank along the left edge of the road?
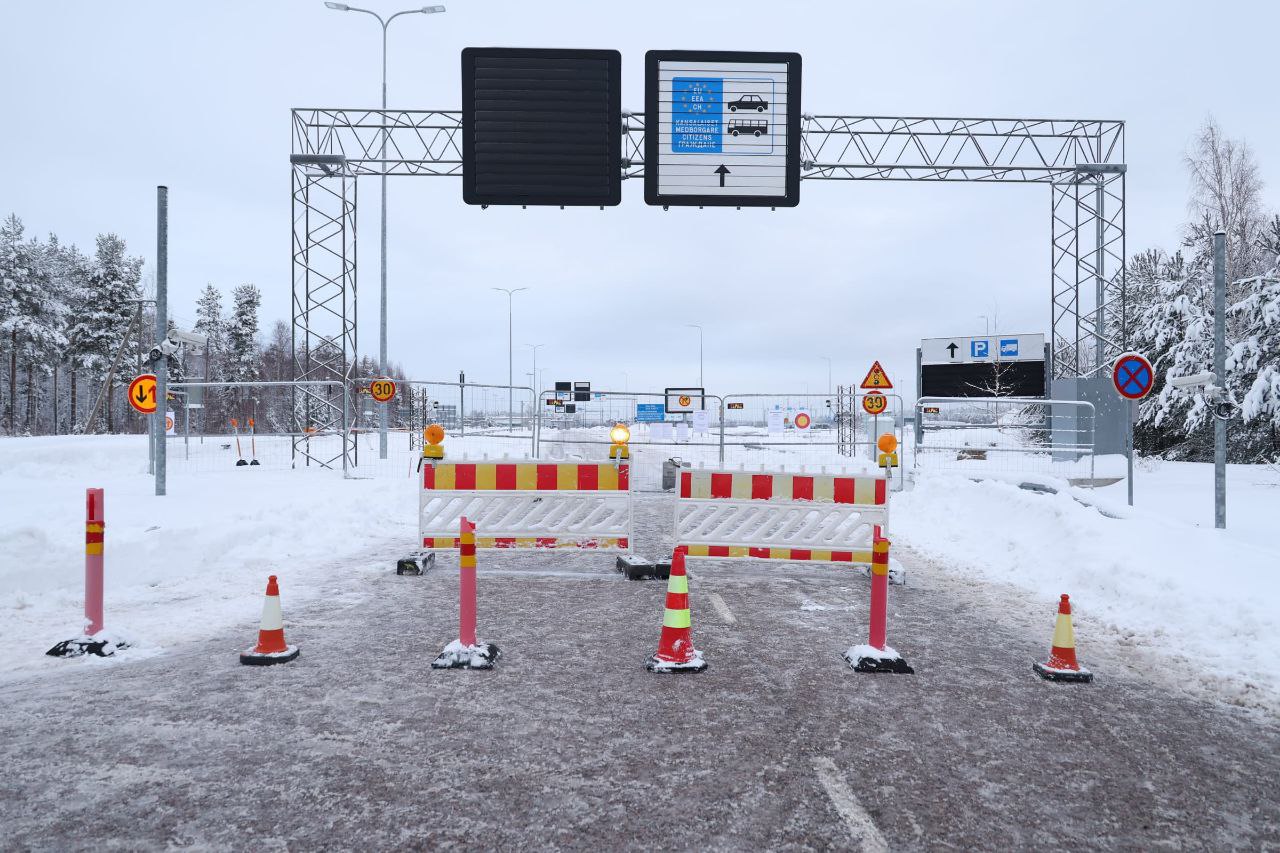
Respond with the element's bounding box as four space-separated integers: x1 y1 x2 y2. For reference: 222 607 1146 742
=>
0 435 417 679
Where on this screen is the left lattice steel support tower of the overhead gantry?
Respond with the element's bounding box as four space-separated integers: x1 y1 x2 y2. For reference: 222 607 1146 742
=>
292 165 357 471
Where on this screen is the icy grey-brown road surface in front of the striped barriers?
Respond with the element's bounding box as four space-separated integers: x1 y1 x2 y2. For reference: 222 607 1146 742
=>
0 498 1280 850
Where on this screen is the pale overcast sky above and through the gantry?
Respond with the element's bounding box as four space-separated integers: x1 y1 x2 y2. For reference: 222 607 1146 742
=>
0 0 1280 393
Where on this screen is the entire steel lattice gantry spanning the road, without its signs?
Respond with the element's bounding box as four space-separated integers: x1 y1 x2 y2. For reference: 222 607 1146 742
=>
291 109 1128 465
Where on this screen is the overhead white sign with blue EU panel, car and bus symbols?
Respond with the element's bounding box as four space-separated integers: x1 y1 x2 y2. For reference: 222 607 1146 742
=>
644 50 800 207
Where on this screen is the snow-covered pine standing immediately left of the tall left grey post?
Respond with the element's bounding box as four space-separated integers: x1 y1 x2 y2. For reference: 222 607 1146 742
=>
69 234 142 432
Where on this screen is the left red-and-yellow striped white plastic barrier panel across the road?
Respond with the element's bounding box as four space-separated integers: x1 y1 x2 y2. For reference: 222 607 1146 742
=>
419 461 632 551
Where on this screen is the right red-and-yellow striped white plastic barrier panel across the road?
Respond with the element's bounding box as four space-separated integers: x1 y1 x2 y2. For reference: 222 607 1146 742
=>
676 470 888 566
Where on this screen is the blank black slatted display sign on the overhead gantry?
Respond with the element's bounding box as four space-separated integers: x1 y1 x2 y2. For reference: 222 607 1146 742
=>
462 47 622 205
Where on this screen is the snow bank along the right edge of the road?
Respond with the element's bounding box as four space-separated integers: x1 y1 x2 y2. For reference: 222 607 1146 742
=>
893 466 1280 704
